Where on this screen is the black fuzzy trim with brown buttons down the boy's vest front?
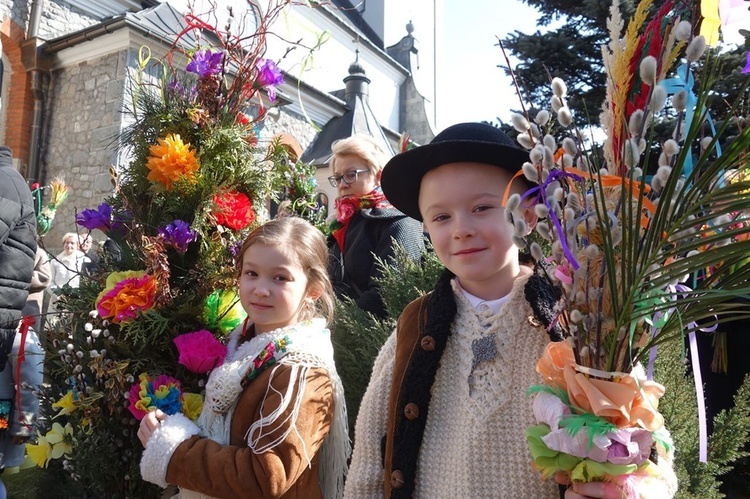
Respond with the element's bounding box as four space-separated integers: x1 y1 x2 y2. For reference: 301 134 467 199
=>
391 269 457 498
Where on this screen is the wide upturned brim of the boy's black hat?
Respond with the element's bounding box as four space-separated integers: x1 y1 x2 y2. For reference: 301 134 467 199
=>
380 140 529 221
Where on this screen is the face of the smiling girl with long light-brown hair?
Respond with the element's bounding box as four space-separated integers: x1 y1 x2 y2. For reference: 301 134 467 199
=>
240 243 319 334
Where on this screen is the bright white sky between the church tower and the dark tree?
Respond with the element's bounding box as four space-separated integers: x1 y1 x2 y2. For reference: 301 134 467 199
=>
435 0 539 132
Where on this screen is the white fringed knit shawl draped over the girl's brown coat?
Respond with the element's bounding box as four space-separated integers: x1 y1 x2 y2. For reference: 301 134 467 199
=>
179 318 351 499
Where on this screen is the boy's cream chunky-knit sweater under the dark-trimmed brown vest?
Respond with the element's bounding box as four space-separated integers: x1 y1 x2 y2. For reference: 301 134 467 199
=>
344 278 676 499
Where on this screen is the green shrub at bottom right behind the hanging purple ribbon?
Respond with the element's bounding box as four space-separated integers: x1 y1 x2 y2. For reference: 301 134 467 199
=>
655 340 750 499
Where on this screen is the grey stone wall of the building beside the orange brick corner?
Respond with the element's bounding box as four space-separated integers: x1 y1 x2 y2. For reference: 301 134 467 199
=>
42 51 127 252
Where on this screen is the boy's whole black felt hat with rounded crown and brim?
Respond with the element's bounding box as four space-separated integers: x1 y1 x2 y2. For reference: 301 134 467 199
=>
380 123 529 220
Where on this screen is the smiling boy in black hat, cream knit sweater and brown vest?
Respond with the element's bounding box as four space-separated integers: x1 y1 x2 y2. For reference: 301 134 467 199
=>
345 123 676 499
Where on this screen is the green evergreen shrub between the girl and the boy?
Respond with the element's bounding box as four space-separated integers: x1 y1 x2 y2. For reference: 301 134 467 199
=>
331 241 443 434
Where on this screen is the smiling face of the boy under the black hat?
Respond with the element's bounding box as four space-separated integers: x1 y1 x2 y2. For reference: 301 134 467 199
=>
419 163 519 300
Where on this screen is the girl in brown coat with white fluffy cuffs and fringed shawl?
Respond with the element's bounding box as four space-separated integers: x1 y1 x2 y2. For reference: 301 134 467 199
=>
138 217 350 499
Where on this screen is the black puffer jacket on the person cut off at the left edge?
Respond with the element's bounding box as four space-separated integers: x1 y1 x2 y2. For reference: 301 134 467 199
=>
0 146 37 371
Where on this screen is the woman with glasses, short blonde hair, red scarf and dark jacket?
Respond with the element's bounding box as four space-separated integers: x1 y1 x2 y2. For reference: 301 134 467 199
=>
328 136 424 318
